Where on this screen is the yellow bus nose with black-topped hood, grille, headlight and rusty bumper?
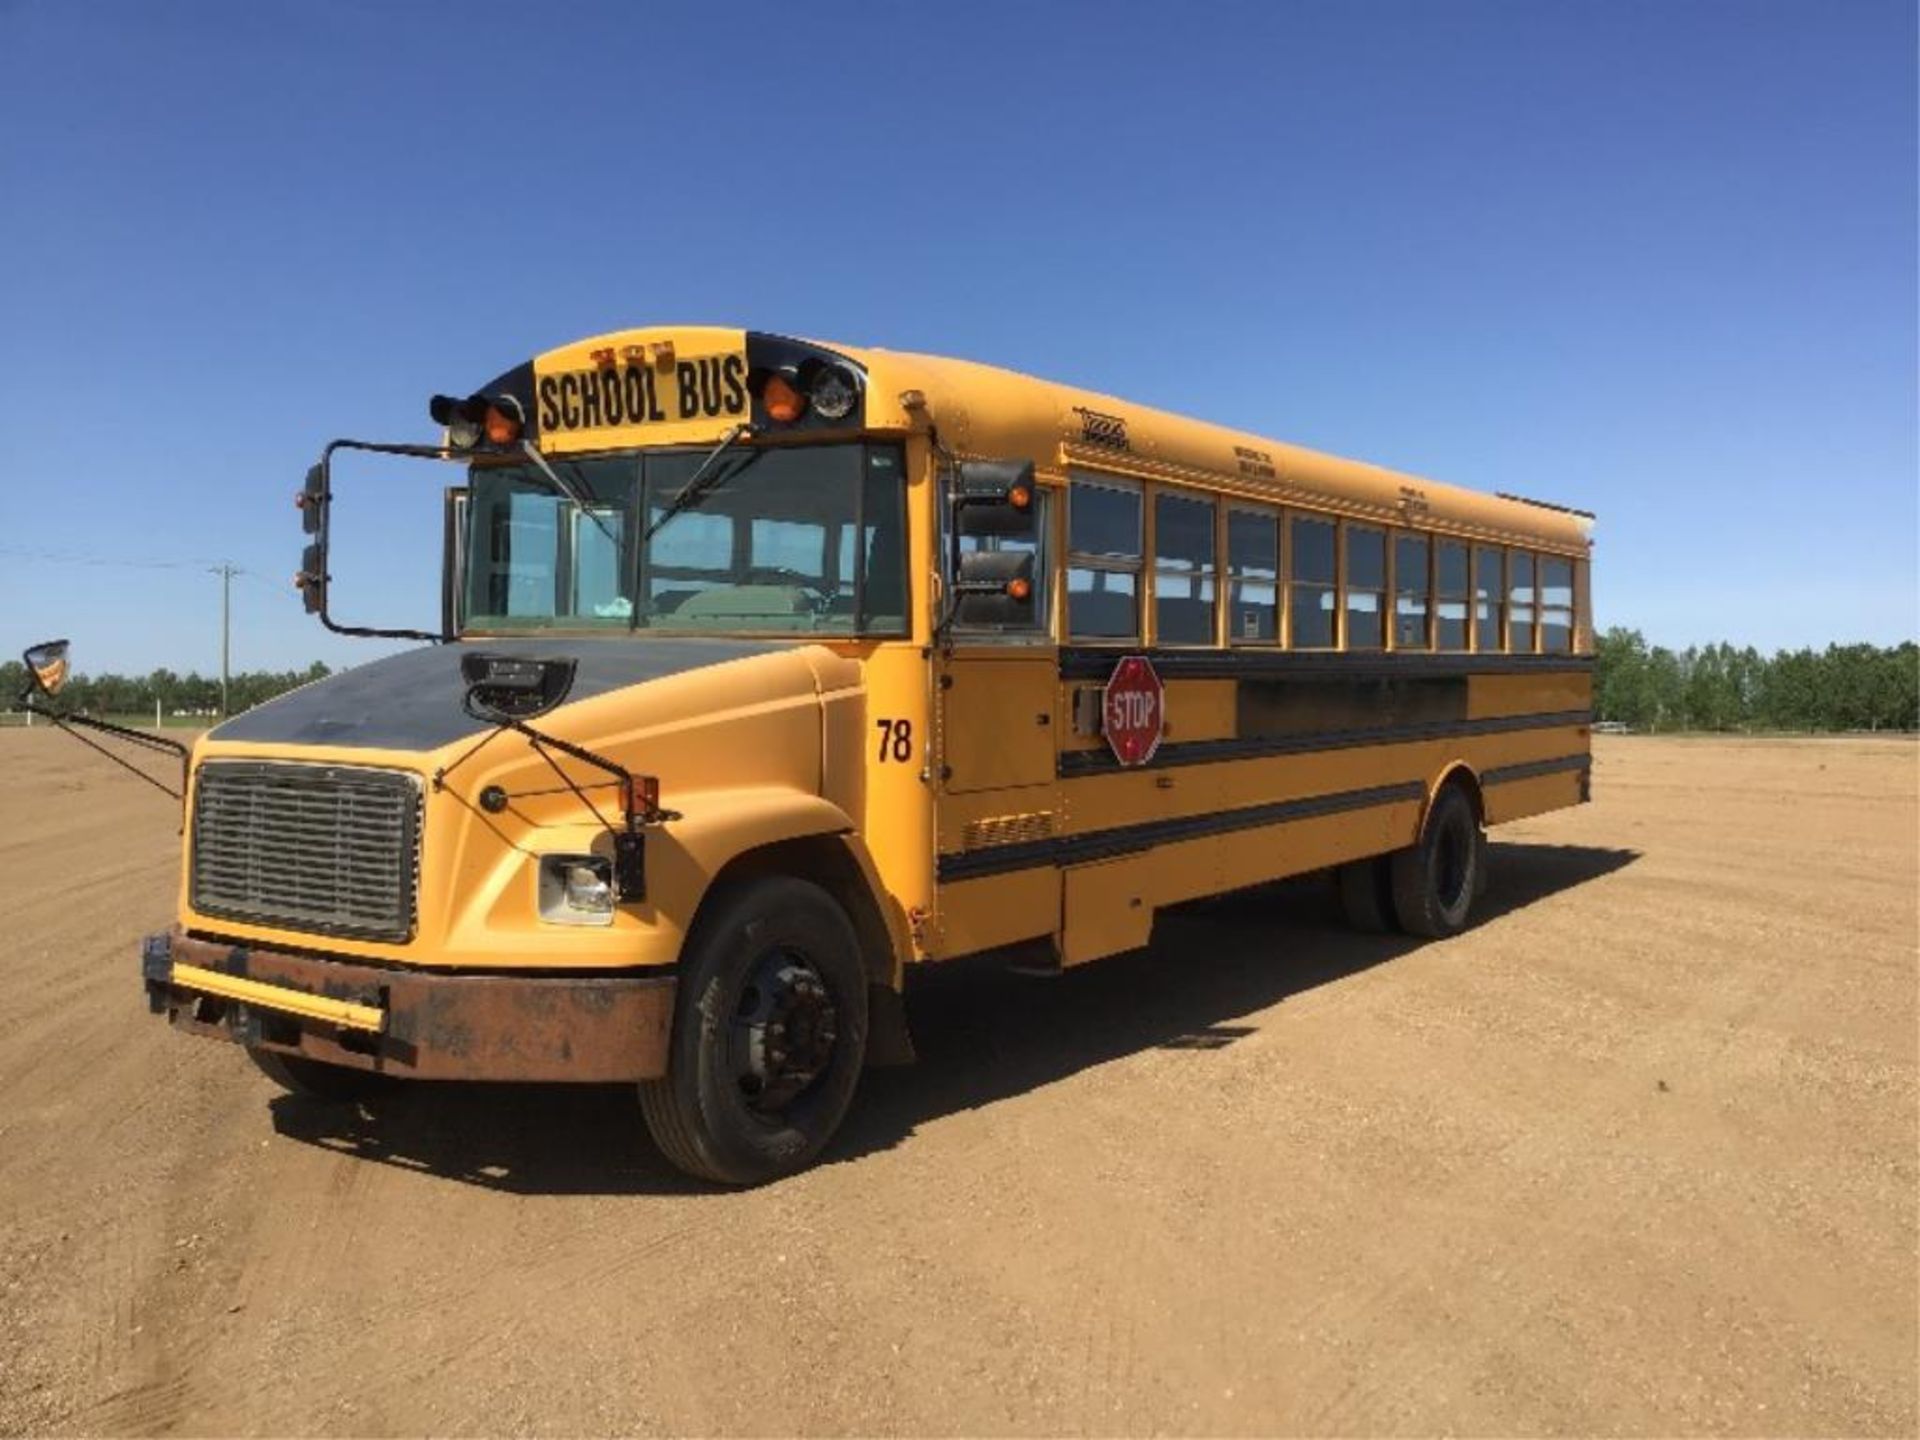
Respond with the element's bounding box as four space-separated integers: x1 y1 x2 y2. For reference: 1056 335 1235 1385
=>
148 639 862 1081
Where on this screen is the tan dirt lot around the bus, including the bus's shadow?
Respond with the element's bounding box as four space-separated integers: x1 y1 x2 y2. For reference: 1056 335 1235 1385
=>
0 732 1920 1434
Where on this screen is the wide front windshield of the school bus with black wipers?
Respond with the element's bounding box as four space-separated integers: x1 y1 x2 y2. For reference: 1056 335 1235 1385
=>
465 444 906 636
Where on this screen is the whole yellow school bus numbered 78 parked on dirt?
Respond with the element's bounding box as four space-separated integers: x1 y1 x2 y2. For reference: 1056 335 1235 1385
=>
18 328 1592 1183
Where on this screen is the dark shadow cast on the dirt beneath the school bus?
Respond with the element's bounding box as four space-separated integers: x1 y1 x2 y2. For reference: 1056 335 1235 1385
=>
273 841 1640 1194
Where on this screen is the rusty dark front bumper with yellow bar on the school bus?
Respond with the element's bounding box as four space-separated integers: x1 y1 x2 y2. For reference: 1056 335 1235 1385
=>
140 929 674 1081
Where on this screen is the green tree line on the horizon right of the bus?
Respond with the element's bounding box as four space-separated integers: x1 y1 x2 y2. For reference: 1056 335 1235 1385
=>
1594 628 1920 730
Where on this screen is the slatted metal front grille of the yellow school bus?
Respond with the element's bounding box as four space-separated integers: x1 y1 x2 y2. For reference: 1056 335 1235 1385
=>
190 760 420 941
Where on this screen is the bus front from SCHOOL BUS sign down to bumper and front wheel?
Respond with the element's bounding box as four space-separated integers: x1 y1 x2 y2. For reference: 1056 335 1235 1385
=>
142 330 933 1181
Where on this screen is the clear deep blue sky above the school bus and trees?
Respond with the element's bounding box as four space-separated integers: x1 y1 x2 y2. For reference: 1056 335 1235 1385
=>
0 0 1920 670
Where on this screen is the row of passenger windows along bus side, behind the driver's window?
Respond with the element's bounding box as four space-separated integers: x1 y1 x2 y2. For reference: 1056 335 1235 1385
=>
1066 476 1574 653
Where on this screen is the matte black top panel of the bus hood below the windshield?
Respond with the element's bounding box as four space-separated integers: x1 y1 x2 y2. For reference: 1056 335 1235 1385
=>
207 636 791 751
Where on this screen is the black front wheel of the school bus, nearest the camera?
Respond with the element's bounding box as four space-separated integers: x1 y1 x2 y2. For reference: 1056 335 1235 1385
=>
639 877 868 1185
